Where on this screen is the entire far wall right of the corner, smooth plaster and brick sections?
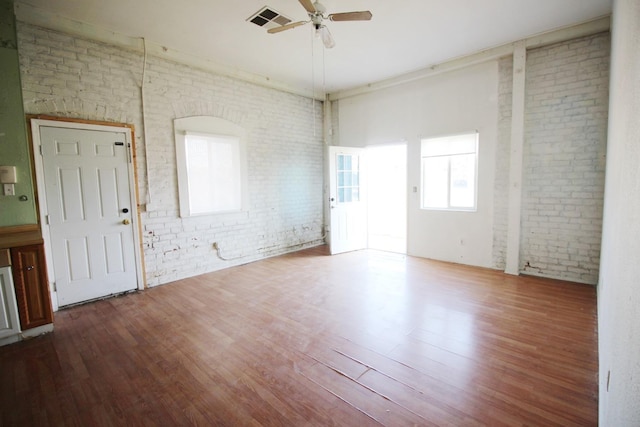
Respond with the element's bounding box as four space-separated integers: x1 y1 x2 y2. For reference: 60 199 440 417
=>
333 32 610 284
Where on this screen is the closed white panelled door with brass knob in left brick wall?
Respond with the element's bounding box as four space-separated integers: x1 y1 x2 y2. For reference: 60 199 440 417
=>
39 126 137 306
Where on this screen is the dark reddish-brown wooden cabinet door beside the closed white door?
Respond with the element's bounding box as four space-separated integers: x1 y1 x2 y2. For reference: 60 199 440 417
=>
11 245 53 330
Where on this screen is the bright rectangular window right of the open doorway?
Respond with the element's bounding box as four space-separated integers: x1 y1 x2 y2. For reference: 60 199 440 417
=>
421 132 478 211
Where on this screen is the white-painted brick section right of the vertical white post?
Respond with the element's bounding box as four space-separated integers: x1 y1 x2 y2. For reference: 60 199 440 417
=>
520 33 610 284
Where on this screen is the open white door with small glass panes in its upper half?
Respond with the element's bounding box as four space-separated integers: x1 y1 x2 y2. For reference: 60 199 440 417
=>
329 146 367 254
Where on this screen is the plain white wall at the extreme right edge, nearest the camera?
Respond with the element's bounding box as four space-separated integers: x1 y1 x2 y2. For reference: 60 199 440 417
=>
598 0 640 427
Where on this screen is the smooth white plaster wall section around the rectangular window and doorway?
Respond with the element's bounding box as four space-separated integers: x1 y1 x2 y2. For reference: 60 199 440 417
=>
338 61 498 267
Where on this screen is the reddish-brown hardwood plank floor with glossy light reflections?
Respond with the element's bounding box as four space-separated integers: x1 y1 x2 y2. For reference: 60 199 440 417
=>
0 247 598 426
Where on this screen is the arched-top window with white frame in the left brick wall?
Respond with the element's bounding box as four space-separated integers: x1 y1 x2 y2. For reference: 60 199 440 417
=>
174 117 246 217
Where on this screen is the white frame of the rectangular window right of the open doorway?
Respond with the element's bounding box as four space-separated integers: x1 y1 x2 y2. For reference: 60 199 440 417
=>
420 131 480 212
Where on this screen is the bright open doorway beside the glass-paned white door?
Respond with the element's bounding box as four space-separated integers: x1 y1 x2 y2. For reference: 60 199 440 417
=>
367 143 407 254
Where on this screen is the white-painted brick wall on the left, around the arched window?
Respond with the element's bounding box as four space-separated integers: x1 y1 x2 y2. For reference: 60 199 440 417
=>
18 22 323 286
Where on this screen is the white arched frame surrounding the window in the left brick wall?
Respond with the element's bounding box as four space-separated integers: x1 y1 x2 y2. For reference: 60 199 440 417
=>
174 116 248 218
